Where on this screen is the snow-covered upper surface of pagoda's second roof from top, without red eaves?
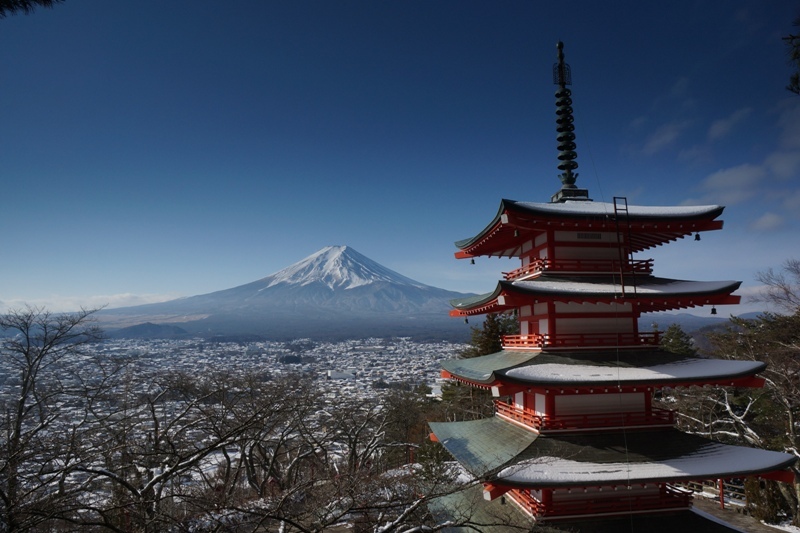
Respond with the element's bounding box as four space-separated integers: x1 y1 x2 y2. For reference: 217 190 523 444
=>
450 274 742 309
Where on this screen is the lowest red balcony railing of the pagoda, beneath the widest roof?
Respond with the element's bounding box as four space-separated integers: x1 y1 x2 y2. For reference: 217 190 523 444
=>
507 485 692 519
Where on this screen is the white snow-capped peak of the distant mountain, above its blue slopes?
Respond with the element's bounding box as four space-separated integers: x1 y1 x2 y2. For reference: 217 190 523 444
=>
264 246 425 290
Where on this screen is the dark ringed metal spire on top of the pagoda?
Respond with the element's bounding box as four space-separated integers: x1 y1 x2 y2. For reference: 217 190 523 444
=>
550 41 590 202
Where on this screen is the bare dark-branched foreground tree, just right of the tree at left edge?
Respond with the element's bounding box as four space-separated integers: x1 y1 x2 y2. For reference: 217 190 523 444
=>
72 372 290 532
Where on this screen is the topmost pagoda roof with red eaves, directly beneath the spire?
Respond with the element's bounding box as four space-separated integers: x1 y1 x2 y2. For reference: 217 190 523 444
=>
455 199 725 259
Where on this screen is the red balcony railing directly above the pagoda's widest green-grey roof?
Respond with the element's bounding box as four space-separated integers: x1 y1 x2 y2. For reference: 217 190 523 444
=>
494 400 675 432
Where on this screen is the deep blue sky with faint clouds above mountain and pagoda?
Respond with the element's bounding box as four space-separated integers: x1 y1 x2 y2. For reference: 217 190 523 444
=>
0 0 800 315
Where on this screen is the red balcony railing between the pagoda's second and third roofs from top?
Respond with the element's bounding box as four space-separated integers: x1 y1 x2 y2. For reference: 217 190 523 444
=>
503 331 661 350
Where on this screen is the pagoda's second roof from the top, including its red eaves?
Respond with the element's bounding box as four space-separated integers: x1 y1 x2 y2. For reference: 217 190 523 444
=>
450 274 741 316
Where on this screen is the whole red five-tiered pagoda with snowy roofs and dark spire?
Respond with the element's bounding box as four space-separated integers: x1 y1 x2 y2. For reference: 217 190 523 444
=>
431 43 795 524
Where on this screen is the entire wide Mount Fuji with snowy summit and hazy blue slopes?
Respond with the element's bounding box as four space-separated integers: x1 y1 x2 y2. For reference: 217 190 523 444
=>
98 246 476 341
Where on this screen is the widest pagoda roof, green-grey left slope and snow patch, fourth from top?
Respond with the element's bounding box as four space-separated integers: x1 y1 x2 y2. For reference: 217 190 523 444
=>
430 416 797 488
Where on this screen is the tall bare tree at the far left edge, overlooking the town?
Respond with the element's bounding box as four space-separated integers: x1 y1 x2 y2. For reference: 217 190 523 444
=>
0 307 104 531
